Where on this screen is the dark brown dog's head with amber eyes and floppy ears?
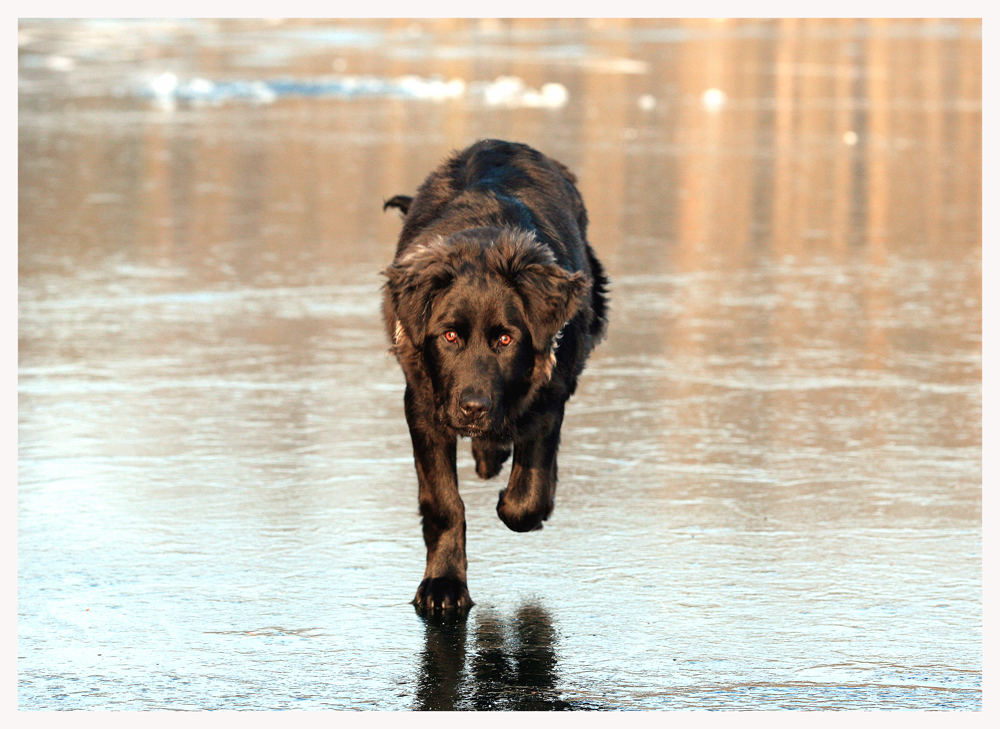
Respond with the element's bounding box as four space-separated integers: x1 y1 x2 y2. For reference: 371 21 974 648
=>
385 228 589 437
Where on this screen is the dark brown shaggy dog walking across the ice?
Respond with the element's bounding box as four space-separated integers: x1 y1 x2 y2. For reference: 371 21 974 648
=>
383 140 608 611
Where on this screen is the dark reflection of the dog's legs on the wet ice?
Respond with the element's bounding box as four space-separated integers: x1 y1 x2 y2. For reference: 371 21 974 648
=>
414 603 574 711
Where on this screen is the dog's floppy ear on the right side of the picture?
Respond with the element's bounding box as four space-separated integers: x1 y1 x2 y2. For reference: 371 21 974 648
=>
493 229 591 353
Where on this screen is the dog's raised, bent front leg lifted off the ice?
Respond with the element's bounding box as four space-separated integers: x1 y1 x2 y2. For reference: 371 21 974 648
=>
497 403 565 532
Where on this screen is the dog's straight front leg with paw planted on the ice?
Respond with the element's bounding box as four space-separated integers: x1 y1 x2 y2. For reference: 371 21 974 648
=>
405 387 472 612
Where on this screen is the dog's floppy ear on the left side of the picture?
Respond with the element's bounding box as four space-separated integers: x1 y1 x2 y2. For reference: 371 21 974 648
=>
383 244 454 347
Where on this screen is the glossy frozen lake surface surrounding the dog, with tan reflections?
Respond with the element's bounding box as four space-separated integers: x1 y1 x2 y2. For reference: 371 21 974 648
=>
17 20 982 710
